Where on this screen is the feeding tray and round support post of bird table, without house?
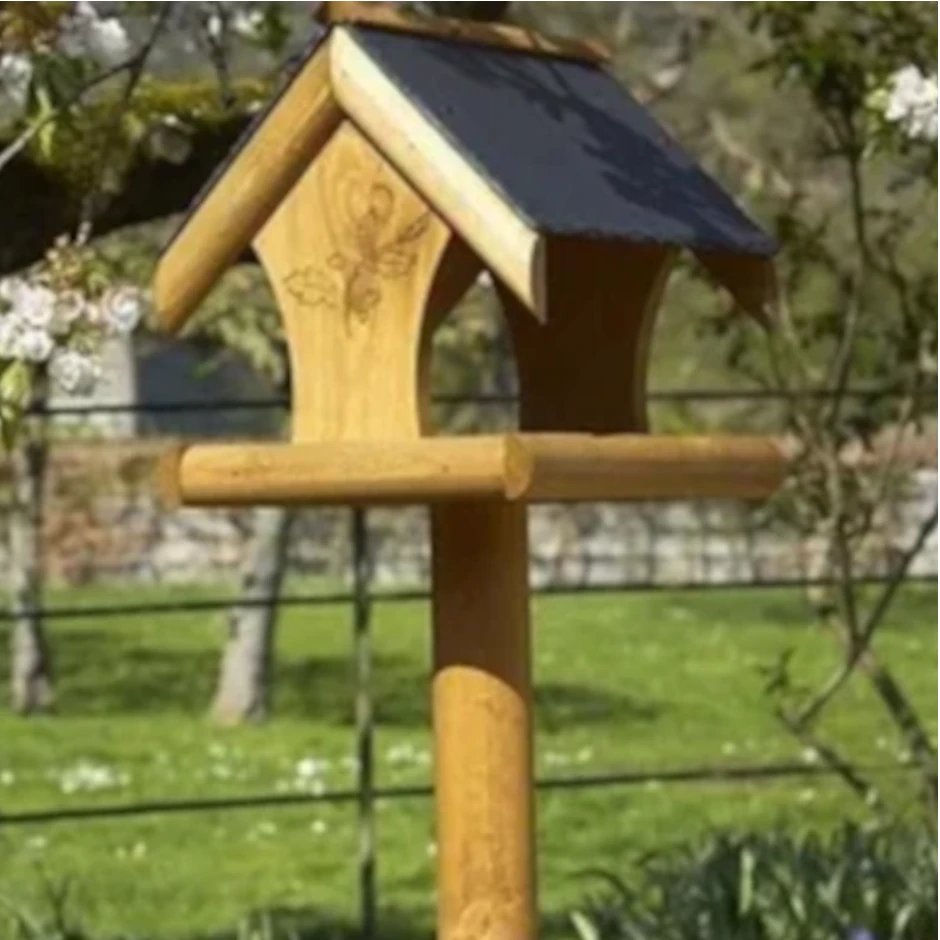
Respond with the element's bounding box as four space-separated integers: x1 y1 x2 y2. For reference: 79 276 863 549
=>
164 434 784 940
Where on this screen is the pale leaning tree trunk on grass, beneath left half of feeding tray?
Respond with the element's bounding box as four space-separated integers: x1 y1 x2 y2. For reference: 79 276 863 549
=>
212 507 295 725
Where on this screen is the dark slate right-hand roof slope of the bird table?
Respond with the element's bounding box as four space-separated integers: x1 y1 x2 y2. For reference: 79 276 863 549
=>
353 26 776 256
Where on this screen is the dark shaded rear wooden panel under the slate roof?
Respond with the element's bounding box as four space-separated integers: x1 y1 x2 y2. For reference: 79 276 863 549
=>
499 238 676 434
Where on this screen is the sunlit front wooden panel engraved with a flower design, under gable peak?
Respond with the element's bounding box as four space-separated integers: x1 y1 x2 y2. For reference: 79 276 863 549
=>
254 122 468 442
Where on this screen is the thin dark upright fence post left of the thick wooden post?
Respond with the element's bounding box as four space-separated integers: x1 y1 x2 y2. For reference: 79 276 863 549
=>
351 508 378 940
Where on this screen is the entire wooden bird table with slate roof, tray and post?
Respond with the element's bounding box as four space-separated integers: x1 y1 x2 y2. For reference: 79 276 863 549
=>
154 0 786 940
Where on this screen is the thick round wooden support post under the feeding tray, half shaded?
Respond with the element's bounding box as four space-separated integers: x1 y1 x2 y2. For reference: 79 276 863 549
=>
432 502 537 940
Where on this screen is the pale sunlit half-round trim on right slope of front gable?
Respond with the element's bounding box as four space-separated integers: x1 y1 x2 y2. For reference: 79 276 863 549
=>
331 32 545 316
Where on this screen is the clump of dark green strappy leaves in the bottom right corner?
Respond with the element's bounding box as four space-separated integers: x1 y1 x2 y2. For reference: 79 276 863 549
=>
571 826 940 940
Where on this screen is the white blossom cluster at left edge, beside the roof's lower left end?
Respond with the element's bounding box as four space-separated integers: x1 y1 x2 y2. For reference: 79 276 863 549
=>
0 277 145 395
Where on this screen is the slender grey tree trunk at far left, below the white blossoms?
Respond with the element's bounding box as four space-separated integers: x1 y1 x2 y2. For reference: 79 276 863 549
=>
8 396 54 715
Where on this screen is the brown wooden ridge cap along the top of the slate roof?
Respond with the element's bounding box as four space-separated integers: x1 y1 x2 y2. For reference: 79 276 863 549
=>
317 0 613 65
